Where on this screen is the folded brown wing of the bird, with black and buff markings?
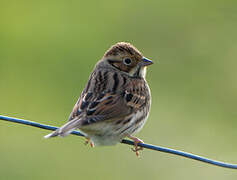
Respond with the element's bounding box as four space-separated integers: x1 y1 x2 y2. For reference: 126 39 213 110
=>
69 82 149 125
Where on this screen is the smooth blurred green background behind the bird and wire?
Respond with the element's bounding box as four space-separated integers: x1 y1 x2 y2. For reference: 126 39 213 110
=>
0 0 237 180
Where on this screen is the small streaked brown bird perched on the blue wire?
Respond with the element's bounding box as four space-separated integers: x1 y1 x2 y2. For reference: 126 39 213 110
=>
45 42 153 156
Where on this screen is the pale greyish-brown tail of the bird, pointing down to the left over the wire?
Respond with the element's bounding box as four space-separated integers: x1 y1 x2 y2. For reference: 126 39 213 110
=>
44 119 80 139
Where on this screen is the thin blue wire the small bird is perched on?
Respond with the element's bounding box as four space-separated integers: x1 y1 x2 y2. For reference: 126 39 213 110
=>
0 115 237 169
